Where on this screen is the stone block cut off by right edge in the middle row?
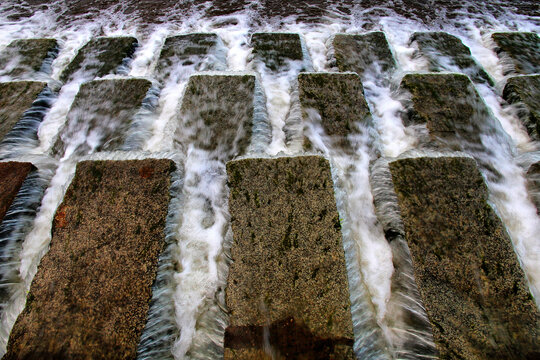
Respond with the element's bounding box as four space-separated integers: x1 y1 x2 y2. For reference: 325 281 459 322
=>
503 75 540 140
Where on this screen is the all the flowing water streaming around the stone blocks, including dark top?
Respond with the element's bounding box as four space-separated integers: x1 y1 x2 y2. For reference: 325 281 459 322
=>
0 0 540 359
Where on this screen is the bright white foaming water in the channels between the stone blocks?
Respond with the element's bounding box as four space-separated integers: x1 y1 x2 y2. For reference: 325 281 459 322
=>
0 4 540 359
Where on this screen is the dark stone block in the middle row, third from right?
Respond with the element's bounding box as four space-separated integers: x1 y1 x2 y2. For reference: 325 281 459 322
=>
298 73 371 152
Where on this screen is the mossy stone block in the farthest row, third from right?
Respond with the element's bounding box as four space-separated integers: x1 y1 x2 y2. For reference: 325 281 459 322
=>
333 31 396 76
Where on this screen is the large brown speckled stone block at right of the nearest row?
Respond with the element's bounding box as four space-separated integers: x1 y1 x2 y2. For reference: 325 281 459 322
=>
389 157 540 359
